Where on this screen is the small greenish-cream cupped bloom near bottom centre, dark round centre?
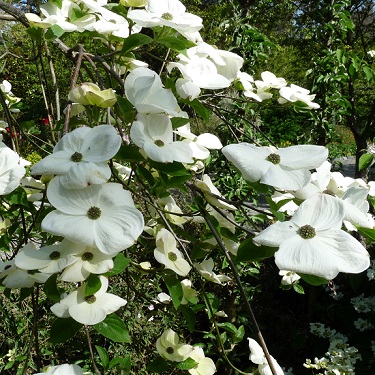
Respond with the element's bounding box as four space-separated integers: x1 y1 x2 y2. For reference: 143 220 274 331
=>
156 328 193 362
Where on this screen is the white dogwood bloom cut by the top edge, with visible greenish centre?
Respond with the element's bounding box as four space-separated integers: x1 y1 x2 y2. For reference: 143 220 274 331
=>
128 0 203 32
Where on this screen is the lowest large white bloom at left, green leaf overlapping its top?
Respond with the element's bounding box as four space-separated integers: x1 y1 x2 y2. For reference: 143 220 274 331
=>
51 276 127 325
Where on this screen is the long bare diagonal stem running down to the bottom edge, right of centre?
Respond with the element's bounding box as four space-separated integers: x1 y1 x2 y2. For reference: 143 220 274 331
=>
201 207 277 375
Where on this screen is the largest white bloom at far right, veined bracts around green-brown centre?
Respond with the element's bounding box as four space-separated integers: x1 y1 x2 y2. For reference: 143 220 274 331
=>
254 194 370 280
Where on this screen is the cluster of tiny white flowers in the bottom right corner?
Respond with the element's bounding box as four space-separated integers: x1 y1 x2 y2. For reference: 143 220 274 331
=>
304 323 362 375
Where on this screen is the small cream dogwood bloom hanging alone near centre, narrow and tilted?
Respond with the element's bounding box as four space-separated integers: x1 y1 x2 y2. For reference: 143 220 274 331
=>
154 228 191 276
